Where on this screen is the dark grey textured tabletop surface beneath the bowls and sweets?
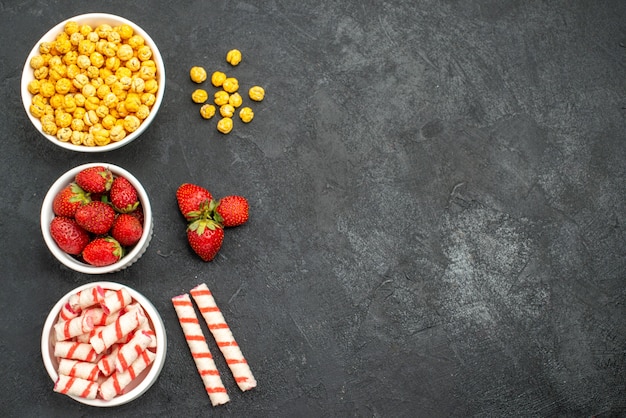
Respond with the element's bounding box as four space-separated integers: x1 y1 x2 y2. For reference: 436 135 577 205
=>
0 0 626 417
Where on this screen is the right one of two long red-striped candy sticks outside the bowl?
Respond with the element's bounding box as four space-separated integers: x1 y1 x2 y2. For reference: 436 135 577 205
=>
190 283 257 391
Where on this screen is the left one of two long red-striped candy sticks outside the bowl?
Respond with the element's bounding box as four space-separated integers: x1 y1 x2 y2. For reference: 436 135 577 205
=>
172 293 230 406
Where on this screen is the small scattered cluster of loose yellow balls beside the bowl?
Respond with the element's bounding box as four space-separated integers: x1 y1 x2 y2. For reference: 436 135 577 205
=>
189 49 265 134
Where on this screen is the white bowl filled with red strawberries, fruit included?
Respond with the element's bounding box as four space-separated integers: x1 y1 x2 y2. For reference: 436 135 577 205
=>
41 163 153 274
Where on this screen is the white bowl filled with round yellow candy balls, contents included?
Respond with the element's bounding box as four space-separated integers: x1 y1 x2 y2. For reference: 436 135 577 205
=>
21 13 165 152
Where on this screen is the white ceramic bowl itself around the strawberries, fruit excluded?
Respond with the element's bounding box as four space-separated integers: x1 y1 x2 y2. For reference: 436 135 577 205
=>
41 163 153 274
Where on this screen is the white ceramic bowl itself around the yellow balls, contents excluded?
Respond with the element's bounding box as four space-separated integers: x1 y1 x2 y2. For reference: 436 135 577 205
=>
21 13 165 152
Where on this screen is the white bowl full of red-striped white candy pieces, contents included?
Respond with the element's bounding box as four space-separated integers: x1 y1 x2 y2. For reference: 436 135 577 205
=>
41 282 167 407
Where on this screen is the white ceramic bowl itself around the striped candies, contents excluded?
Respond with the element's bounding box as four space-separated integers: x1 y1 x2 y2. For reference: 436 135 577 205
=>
41 282 167 407
